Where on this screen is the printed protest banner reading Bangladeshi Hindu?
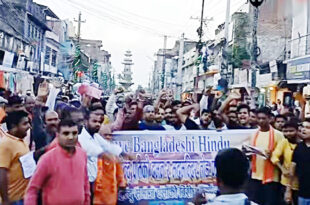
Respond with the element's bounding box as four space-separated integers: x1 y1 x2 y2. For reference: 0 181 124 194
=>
114 130 255 205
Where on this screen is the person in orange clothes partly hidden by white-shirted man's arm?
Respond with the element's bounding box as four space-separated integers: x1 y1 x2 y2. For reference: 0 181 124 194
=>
93 125 126 205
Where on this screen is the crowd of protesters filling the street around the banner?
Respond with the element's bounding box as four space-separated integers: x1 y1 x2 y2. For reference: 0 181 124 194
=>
0 82 310 205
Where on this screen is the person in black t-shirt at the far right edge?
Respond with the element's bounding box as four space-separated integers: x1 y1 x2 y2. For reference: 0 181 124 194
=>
291 118 310 205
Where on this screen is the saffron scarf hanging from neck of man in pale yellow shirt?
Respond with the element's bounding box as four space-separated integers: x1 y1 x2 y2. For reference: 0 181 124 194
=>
252 126 275 184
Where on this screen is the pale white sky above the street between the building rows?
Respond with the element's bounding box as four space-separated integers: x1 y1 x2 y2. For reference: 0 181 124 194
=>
34 0 246 88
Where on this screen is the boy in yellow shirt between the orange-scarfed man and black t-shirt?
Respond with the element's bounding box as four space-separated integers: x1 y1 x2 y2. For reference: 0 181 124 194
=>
271 121 298 204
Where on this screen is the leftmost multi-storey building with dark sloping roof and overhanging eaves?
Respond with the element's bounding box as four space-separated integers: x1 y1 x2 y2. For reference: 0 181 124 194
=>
0 0 58 94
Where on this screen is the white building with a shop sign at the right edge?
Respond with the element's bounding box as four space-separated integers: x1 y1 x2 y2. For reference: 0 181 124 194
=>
285 1 310 117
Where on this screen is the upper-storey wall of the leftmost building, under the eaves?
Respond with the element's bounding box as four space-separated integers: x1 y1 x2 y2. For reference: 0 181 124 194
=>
0 0 50 72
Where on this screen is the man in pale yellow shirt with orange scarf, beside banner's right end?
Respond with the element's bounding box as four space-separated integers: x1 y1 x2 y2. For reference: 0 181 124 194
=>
248 107 284 205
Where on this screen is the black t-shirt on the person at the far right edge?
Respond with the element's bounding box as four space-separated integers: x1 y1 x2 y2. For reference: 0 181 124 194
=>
293 142 310 199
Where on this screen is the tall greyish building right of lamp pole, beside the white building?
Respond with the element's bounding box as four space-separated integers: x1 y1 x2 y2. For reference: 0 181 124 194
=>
249 1 294 105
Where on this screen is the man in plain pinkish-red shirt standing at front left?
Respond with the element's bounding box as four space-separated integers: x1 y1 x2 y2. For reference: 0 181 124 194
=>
24 120 90 205
